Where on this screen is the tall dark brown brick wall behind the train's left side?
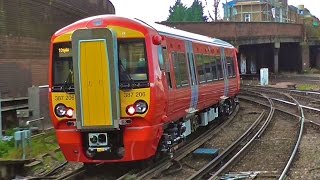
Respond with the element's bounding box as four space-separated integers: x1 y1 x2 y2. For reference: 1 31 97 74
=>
0 0 115 97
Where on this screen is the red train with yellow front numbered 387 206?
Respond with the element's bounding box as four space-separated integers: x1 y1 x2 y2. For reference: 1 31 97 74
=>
48 15 240 164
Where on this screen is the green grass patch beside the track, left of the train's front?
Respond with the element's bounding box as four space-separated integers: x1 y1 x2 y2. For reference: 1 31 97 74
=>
0 129 61 160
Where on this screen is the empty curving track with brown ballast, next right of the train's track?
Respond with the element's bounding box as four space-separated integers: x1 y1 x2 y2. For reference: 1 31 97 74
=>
184 89 304 179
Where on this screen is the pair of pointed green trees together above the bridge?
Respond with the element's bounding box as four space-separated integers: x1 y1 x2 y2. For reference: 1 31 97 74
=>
167 0 208 22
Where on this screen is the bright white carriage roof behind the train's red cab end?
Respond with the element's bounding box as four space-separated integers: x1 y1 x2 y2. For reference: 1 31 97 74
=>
137 19 234 48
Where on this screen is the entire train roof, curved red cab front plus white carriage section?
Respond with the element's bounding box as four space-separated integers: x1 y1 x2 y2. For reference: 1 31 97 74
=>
55 14 234 48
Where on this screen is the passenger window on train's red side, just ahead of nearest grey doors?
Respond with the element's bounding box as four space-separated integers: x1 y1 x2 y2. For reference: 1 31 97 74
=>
172 53 189 88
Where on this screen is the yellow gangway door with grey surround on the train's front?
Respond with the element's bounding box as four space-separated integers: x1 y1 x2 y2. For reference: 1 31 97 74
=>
72 28 120 129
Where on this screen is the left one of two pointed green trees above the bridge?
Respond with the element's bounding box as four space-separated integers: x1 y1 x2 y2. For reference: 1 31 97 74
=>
167 0 187 22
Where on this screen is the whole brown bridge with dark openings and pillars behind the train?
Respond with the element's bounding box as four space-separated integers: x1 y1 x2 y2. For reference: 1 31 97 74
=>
161 22 320 74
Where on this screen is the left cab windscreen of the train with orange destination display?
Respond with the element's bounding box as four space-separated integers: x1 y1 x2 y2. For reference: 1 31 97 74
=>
52 42 74 91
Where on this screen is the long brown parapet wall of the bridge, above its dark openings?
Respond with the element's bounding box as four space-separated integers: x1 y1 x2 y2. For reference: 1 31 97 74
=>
161 22 304 45
